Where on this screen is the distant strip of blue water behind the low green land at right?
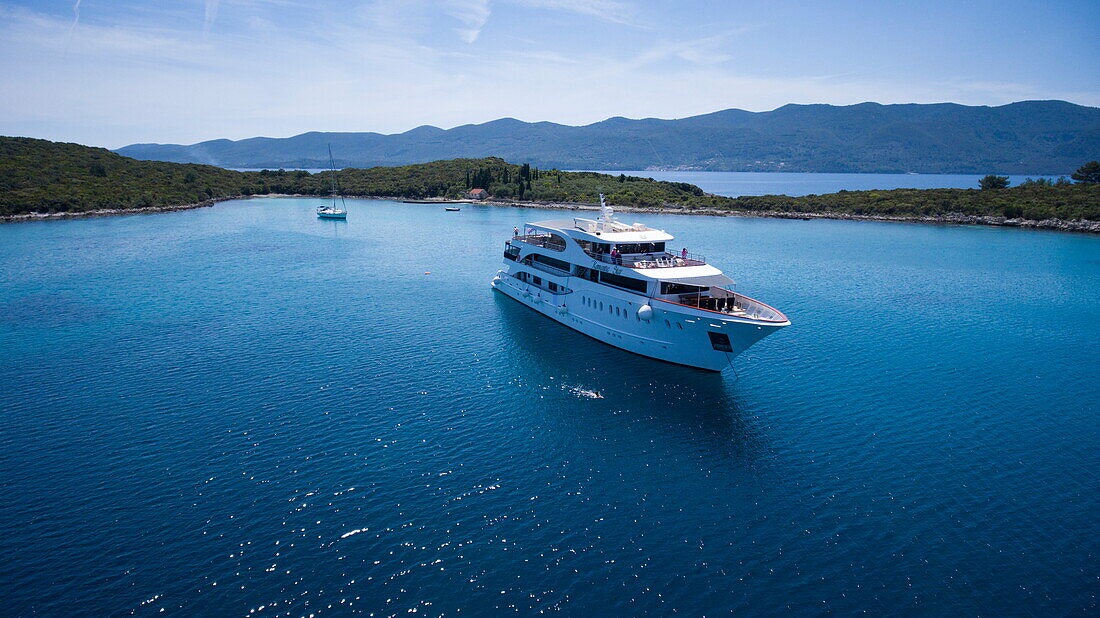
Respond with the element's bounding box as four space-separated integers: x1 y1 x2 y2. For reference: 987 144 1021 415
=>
592 169 1058 197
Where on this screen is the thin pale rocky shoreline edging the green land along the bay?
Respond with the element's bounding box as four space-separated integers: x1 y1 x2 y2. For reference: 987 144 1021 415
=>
0 194 1100 234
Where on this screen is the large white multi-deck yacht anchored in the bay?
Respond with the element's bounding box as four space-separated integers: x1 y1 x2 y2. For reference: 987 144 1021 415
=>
491 196 791 372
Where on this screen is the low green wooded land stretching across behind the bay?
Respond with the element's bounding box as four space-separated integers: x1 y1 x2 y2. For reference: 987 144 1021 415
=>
0 137 1100 231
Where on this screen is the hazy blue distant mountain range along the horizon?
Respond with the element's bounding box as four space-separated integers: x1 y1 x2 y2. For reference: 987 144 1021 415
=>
116 101 1100 175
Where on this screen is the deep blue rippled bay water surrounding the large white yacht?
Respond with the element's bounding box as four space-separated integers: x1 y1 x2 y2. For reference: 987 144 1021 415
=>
0 199 1100 616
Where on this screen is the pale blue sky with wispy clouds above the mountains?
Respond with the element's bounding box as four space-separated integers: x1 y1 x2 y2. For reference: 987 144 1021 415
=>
0 0 1100 147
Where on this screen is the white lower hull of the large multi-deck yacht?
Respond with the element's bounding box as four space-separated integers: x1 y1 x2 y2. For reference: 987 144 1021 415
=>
491 271 790 372
